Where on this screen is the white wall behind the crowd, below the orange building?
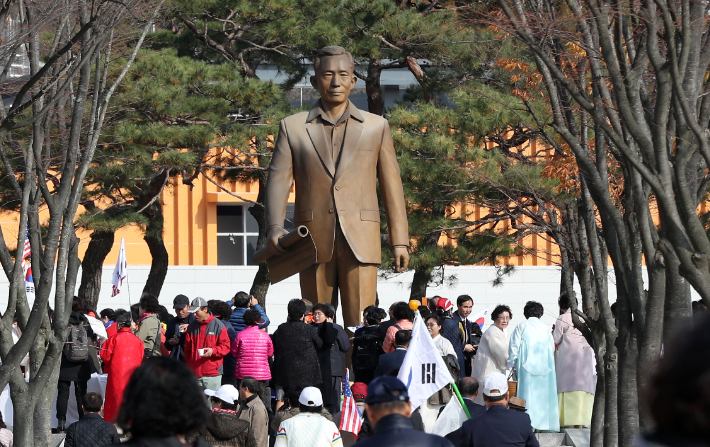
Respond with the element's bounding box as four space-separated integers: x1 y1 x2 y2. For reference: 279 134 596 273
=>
0 265 632 332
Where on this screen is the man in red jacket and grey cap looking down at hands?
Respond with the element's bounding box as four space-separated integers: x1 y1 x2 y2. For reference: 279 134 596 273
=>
185 297 231 391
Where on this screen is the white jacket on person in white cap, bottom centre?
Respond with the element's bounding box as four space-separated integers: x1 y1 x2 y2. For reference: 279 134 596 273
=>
274 413 343 447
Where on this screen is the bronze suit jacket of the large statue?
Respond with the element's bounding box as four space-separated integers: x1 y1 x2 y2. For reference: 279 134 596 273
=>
265 104 409 264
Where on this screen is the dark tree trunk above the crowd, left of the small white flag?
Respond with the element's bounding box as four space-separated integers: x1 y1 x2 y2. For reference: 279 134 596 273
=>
79 231 116 311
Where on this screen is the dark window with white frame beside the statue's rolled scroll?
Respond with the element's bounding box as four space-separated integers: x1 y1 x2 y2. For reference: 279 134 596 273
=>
217 204 293 265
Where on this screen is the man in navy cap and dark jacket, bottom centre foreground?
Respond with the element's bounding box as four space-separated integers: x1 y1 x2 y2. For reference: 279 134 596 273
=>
357 376 453 447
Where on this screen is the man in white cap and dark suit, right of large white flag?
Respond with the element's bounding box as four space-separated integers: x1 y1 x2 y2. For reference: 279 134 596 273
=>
459 372 540 447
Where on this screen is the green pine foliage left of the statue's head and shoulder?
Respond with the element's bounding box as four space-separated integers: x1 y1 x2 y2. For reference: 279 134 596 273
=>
84 48 292 230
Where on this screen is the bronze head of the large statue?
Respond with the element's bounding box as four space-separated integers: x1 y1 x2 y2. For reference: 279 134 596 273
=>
311 46 357 107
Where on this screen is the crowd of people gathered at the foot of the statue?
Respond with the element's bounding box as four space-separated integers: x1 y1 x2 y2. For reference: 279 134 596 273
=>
41 292 707 447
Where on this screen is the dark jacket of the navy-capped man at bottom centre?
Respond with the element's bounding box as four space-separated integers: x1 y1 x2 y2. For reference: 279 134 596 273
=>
357 413 453 447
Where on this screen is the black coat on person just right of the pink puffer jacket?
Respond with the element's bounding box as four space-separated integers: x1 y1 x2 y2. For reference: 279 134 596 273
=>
271 321 330 390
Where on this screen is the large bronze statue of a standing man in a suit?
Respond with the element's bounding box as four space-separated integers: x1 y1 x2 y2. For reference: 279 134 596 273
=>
265 46 409 326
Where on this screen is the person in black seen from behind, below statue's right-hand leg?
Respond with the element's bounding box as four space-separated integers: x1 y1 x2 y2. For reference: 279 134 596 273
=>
352 306 387 384
